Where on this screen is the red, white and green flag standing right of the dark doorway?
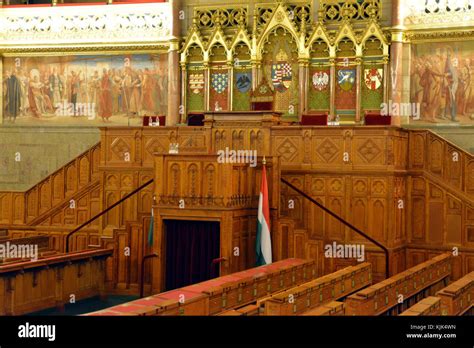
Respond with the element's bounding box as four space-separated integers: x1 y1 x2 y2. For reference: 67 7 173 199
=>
256 165 272 266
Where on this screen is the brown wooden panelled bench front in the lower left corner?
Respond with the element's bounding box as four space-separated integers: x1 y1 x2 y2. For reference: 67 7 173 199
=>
0 250 112 315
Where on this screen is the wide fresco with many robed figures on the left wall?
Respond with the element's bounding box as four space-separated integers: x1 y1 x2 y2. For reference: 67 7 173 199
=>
3 54 168 126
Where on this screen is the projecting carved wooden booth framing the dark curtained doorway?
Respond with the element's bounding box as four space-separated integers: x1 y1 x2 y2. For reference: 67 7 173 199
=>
153 154 280 291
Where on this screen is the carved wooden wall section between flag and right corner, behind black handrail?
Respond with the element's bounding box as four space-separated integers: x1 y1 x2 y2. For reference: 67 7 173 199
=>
272 127 408 279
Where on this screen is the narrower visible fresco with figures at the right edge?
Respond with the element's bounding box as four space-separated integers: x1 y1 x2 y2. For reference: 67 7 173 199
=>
410 41 474 124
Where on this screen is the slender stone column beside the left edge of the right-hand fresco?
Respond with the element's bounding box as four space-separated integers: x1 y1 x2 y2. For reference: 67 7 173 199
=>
389 0 403 126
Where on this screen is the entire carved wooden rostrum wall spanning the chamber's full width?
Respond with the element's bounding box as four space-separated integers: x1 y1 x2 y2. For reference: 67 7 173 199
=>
0 123 474 289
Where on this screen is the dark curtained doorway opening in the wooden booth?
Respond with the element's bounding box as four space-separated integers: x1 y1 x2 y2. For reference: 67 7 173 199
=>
165 220 220 290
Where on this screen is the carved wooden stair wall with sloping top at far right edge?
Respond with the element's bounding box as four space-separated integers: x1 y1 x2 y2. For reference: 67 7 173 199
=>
406 130 474 279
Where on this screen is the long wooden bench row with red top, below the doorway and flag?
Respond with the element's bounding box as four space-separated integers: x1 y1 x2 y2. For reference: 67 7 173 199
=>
86 258 317 316
